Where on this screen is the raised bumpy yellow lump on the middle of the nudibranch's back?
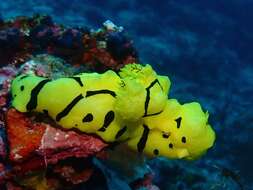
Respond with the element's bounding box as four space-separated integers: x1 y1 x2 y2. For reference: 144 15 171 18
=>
115 64 170 121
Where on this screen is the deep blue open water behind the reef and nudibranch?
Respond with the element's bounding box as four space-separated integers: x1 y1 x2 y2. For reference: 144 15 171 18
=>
0 0 253 189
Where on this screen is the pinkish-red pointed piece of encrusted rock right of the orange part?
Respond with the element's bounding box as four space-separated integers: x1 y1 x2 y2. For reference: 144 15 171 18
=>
37 123 107 164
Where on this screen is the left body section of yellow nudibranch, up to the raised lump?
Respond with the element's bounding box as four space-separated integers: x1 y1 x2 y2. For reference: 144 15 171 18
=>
12 71 123 142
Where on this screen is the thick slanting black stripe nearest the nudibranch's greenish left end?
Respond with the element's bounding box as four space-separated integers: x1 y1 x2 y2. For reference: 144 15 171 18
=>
26 79 50 111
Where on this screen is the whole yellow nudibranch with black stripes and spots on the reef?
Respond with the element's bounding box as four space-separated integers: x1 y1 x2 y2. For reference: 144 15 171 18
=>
11 64 215 159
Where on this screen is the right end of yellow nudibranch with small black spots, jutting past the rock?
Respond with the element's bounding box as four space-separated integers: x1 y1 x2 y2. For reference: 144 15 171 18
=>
128 99 215 160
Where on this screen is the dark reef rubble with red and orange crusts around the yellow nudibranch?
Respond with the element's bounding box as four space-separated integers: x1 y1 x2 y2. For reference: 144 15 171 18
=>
0 15 242 190
